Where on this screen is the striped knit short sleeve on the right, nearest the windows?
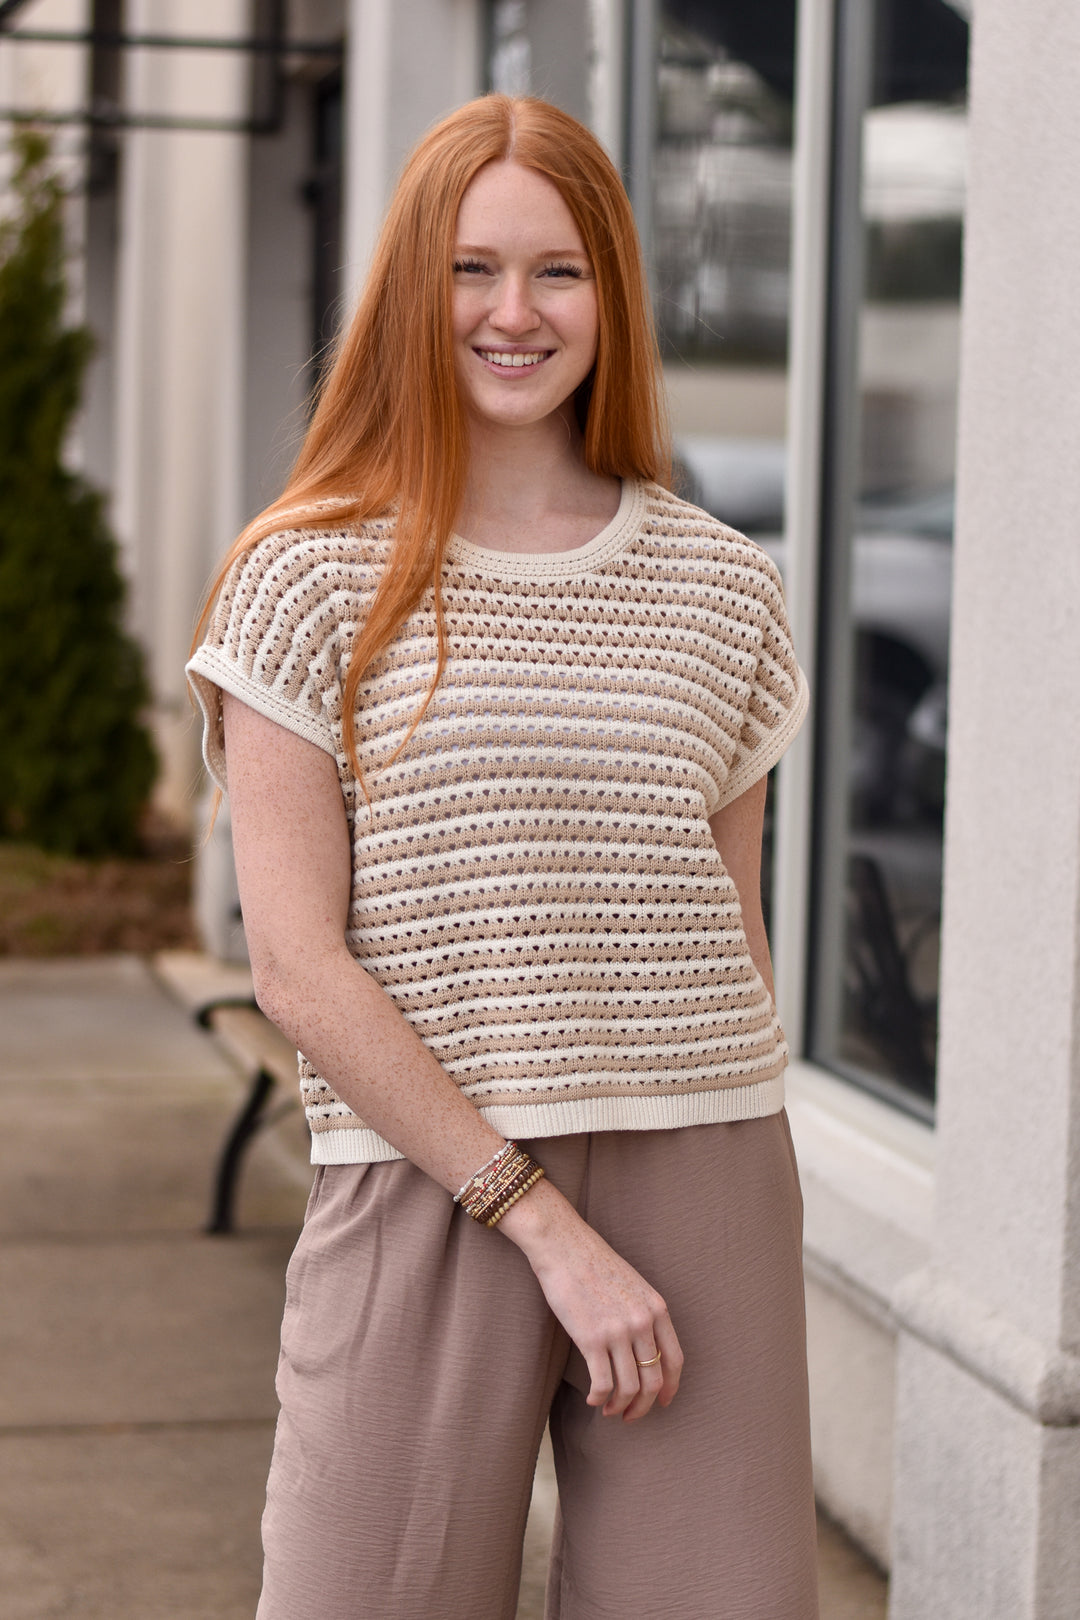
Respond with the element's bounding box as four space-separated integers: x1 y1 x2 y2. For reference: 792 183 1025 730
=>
717 548 810 810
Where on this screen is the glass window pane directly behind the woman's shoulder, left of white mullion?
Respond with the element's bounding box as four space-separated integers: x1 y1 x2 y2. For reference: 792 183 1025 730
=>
648 9 795 939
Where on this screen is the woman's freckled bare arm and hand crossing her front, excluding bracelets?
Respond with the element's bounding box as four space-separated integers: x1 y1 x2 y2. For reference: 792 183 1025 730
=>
223 693 682 1419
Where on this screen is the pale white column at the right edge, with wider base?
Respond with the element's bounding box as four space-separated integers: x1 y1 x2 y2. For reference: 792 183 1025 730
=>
891 0 1080 1620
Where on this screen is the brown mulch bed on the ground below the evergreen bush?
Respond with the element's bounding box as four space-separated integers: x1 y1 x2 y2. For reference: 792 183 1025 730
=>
0 841 198 956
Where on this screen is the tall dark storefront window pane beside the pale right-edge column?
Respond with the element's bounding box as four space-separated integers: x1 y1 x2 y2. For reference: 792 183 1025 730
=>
808 0 967 1115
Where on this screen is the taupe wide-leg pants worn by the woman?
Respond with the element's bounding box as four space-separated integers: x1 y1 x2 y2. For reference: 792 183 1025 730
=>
257 1115 818 1620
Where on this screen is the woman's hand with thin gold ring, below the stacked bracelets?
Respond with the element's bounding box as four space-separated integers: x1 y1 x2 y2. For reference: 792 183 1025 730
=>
500 1181 683 1422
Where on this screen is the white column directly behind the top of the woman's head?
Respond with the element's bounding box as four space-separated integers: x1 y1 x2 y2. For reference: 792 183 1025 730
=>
343 0 483 301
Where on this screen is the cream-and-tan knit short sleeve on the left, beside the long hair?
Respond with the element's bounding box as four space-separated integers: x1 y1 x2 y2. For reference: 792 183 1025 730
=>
186 530 355 789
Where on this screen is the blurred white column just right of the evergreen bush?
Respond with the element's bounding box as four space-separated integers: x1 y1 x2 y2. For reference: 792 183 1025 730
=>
113 0 248 820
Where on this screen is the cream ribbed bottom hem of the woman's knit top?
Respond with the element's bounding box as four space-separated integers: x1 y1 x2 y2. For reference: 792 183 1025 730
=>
311 1074 784 1165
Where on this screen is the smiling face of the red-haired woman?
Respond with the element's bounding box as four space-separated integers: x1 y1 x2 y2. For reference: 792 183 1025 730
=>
453 162 597 431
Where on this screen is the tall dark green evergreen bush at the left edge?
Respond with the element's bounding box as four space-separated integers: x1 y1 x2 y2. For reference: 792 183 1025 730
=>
0 131 155 855
